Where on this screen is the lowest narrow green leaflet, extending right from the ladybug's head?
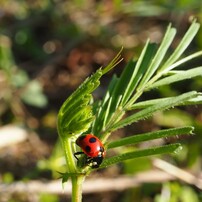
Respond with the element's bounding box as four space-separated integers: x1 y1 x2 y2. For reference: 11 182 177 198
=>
100 143 182 168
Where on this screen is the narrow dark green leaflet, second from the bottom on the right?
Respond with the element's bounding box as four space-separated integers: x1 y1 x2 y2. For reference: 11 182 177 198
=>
106 126 194 149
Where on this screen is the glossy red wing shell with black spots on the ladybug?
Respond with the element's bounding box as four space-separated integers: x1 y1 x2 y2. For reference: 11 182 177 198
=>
76 134 105 158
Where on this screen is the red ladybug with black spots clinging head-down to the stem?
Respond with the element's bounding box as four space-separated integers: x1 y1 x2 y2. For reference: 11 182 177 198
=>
74 134 105 168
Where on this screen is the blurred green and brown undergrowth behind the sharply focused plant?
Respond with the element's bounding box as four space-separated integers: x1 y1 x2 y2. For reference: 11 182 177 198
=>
0 0 202 202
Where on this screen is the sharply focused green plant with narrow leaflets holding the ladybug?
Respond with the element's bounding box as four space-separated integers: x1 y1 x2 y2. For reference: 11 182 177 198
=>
58 21 202 202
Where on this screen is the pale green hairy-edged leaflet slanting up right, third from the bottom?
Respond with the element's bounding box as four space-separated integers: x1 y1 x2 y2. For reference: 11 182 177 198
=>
110 91 198 131
